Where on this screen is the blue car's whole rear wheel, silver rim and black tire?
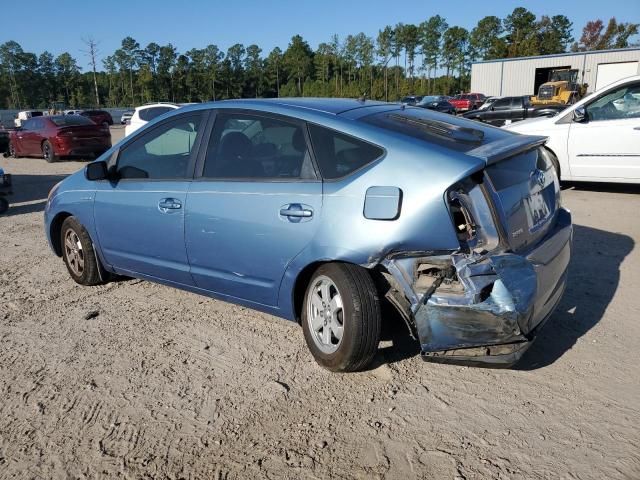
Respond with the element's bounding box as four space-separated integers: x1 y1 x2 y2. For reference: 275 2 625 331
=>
302 263 382 372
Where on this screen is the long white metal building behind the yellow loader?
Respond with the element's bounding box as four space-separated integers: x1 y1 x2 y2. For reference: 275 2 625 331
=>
471 47 640 96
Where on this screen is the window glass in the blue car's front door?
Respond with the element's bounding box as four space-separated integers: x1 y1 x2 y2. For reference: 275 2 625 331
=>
116 114 202 180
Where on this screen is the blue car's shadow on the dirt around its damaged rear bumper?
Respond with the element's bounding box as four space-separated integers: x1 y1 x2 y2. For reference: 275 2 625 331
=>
372 225 634 370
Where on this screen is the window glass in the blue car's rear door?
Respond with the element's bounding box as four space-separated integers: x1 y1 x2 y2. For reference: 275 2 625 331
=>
202 113 315 179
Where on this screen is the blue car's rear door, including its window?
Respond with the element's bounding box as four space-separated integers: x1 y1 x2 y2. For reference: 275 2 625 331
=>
186 111 322 306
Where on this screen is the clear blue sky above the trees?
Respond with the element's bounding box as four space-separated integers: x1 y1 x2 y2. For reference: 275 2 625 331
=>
0 0 640 70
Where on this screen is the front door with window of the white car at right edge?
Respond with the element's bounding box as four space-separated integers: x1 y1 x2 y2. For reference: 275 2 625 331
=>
568 81 640 180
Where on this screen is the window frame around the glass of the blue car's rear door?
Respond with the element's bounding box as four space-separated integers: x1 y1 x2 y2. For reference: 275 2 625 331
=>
194 108 322 183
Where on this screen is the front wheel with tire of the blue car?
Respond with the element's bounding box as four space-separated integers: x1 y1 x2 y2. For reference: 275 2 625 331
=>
60 217 104 286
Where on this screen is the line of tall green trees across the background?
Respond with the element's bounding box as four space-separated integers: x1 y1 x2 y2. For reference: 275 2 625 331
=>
0 7 639 108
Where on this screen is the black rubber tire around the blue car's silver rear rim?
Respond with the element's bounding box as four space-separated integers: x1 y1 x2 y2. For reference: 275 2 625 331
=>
302 263 382 372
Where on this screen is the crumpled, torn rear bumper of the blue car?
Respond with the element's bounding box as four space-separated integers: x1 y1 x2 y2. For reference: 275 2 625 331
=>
385 209 572 367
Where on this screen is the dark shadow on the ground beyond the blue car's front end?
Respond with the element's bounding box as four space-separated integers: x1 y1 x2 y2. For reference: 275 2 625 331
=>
3 174 67 217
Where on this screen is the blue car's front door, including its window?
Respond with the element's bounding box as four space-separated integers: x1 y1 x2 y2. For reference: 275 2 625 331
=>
94 112 205 285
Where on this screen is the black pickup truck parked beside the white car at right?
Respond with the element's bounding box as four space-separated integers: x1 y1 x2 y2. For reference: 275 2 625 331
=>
463 95 566 127
